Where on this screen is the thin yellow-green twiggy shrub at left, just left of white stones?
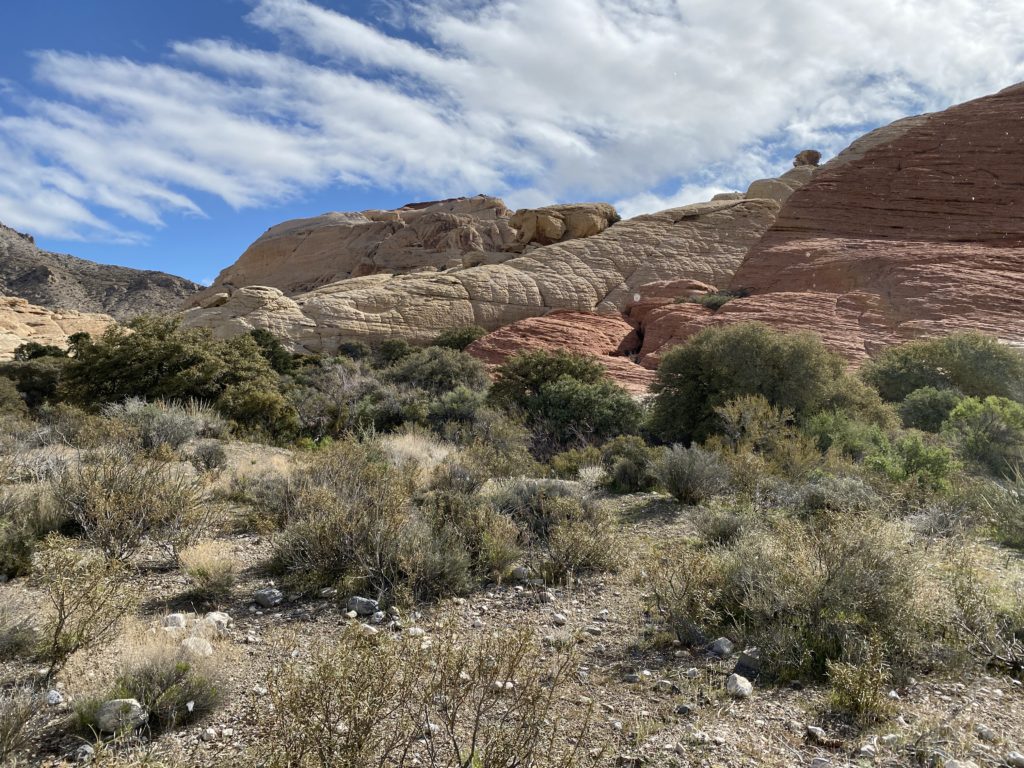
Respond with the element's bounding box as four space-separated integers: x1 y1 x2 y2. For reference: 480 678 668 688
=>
33 536 134 681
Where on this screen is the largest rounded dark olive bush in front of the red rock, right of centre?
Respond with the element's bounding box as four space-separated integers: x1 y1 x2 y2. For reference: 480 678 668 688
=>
649 323 869 443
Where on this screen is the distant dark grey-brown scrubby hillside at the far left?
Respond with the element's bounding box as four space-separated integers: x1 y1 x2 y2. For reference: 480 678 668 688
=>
0 224 200 319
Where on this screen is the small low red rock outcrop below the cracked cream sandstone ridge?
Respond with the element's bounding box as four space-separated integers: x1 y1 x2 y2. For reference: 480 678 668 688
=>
466 311 654 394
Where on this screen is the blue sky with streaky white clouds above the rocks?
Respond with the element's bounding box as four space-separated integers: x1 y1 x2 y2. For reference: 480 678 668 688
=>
0 0 1024 283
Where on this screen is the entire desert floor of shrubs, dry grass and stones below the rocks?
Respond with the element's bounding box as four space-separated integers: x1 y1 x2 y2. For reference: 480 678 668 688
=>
0 317 1024 768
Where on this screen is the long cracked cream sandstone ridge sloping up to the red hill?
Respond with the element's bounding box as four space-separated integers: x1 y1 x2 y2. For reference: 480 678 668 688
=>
184 200 779 352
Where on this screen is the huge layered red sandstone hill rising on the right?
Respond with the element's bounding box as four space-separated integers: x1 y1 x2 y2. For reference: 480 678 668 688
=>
640 85 1024 367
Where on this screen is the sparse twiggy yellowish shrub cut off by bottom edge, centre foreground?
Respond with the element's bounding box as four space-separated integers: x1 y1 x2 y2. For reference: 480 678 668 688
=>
265 627 590 768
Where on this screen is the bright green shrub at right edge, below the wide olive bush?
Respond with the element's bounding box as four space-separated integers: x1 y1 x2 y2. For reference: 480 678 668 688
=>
944 396 1024 474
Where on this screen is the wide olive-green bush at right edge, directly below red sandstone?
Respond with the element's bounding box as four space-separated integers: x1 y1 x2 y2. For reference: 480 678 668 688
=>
861 332 1024 402
